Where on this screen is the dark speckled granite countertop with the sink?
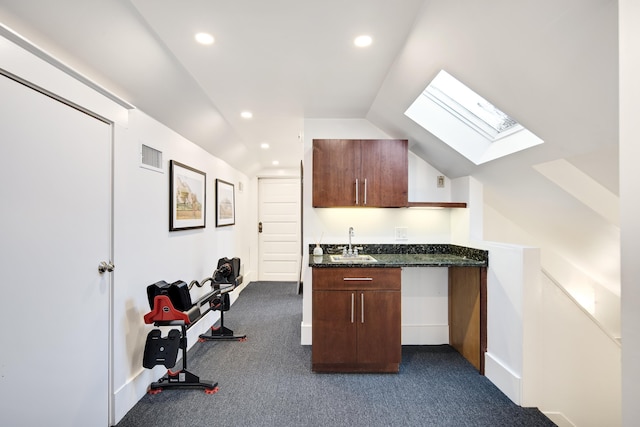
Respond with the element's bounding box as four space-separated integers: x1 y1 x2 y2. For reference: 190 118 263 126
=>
309 244 489 268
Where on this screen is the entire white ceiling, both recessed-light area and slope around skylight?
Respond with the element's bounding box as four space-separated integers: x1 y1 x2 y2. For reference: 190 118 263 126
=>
0 0 618 288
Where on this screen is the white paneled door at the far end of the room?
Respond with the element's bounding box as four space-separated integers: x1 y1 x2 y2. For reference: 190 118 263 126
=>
258 178 301 281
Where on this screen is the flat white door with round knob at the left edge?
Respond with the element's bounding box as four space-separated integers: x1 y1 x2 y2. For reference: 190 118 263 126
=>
0 75 112 427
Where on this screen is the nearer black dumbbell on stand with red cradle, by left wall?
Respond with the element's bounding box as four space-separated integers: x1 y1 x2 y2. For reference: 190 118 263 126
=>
142 281 218 394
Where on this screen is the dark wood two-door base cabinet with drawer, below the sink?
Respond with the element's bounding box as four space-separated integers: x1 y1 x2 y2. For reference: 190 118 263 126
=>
311 268 402 372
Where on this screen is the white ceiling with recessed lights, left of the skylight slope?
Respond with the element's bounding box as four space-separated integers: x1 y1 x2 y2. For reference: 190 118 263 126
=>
0 0 423 175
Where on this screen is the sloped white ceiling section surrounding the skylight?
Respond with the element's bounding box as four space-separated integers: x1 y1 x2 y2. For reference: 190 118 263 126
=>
368 0 618 177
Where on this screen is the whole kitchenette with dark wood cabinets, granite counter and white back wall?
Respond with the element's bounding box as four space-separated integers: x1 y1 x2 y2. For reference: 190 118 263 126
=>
301 133 488 374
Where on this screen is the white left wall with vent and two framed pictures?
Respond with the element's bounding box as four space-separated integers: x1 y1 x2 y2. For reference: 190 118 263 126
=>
0 30 256 422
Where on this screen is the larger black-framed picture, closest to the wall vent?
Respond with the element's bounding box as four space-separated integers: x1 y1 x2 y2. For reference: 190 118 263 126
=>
169 160 207 231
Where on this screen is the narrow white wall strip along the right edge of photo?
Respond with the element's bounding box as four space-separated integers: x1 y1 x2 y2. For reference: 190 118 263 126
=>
618 0 640 426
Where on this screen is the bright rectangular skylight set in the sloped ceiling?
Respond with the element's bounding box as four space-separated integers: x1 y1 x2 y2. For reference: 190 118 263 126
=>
405 70 543 164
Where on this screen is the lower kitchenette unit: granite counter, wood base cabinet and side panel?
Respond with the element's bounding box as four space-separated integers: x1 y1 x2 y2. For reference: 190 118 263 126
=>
309 244 488 374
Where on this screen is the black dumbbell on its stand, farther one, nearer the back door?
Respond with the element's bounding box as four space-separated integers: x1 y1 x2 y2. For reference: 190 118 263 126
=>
198 258 247 342
